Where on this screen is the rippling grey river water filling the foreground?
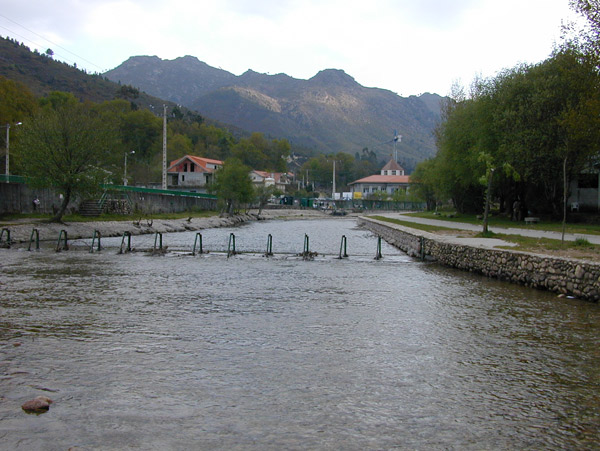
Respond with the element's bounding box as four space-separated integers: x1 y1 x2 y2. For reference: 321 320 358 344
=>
0 219 600 450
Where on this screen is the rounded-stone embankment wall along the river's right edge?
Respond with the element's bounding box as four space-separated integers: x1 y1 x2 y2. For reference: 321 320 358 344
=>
359 218 600 302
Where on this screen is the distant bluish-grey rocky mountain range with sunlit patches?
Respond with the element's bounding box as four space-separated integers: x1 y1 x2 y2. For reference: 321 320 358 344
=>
103 56 442 170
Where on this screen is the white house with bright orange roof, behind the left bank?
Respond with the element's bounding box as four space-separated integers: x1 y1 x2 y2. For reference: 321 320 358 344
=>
167 155 223 192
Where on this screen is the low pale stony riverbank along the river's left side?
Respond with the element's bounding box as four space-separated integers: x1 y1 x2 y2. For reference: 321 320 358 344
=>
2 209 331 243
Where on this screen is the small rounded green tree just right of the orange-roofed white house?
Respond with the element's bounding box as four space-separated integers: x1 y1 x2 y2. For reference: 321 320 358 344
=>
211 158 254 215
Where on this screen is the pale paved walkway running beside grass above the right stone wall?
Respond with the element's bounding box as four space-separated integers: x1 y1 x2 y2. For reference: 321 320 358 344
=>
381 213 600 247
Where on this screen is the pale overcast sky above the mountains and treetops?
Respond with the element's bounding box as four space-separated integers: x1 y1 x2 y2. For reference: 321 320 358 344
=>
0 0 575 96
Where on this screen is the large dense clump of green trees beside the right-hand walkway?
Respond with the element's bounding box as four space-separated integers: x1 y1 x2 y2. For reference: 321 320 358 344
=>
415 47 600 217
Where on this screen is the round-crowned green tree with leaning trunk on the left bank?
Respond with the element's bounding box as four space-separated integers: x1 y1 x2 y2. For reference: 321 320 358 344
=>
17 96 118 222
